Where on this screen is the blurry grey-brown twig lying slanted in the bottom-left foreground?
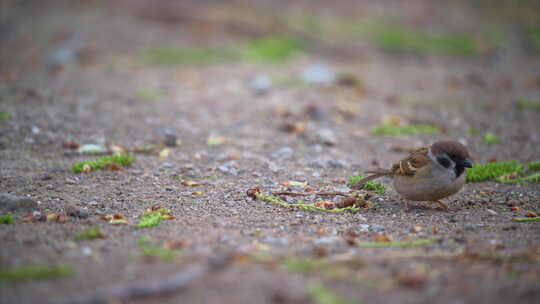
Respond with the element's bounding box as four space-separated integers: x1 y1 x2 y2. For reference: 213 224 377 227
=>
51 265 207 304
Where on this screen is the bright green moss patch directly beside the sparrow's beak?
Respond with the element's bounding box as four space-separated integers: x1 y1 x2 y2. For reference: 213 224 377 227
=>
466 160 523 183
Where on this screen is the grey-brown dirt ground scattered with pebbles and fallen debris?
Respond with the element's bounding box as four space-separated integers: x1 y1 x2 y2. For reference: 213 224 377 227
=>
0 1 540 303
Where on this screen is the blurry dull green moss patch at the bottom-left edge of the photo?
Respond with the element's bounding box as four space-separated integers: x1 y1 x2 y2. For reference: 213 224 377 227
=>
0 265 73 282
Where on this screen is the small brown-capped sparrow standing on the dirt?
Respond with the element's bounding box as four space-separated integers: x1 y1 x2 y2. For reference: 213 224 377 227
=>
352 140 473 211
